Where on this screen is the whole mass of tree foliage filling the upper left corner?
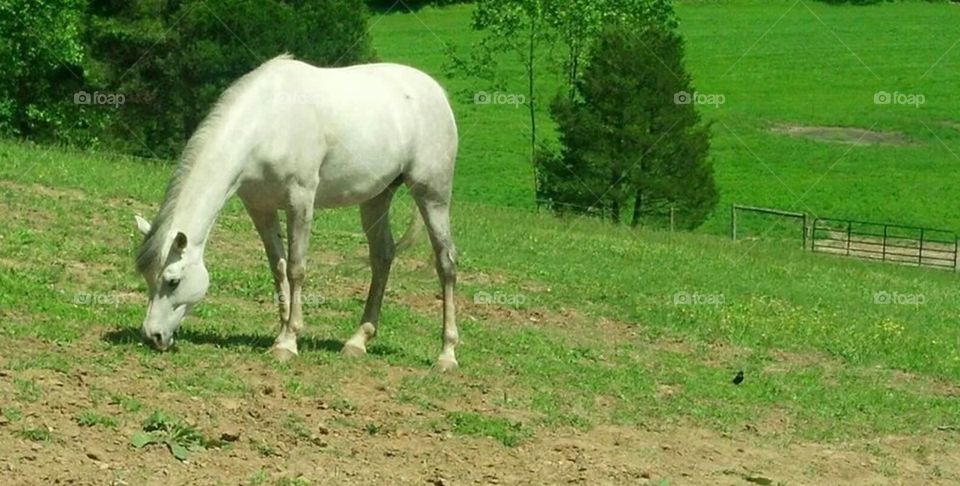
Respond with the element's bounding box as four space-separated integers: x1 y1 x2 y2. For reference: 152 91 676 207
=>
0 0 373 158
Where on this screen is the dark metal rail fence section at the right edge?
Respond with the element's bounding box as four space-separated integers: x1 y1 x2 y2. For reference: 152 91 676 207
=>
810 218 958 269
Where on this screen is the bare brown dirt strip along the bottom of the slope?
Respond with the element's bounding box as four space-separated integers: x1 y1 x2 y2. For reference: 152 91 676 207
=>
0 333 960 485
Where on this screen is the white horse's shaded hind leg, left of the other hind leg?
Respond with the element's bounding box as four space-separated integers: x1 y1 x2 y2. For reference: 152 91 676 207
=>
343 188 395 356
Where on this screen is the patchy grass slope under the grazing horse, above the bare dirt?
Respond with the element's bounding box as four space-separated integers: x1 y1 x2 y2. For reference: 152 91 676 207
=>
0 143 960 482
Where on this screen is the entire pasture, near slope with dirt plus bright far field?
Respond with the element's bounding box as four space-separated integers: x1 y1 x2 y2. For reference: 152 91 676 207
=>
0 1 960 485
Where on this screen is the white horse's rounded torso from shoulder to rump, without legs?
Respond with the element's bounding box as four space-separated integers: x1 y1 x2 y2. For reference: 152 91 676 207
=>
234 58 457 207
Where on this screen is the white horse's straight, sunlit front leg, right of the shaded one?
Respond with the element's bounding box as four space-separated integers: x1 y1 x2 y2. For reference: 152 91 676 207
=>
272 193 313 361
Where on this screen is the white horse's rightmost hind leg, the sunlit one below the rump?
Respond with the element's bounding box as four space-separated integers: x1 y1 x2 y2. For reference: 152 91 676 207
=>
410 186 459 371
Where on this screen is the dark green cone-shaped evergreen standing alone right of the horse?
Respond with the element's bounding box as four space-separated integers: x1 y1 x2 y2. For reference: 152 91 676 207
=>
538 24 717 227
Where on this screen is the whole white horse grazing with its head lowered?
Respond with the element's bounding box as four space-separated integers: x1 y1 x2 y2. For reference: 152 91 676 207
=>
136 56 458 370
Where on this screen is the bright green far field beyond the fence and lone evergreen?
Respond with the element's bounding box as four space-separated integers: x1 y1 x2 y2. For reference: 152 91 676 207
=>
372 0 960 233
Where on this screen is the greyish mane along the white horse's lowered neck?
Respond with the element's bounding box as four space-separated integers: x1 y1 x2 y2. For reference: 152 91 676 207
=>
136 54 293 273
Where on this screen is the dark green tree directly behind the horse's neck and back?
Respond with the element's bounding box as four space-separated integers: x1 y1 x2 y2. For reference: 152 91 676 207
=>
87 0 374 157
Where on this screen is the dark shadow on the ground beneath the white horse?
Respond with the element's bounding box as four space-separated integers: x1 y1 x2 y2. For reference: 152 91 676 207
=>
101 327 403 356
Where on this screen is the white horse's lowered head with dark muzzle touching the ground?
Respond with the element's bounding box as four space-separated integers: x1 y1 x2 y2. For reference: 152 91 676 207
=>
136 216 210 351
